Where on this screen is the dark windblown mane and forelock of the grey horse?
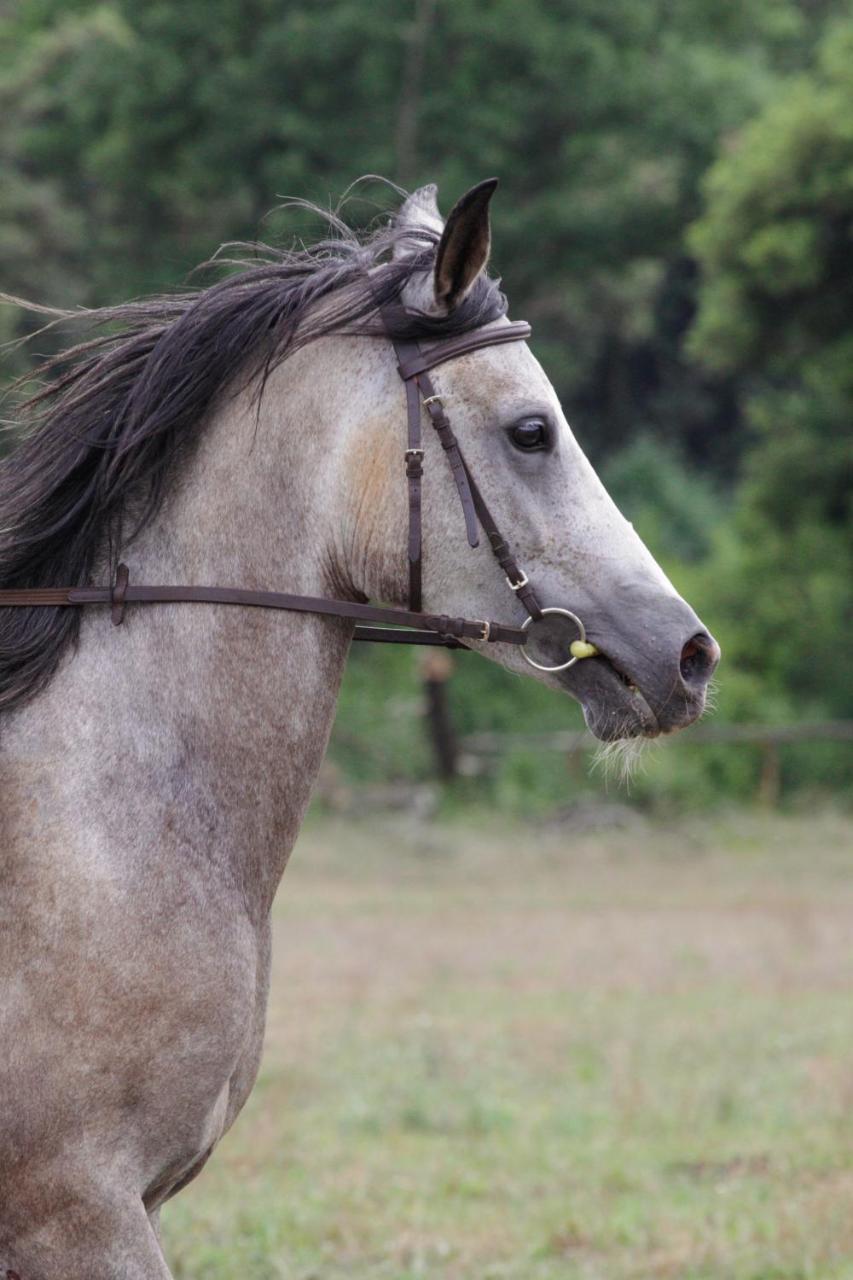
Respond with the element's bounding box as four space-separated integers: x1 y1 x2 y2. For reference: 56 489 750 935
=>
0 201 506 712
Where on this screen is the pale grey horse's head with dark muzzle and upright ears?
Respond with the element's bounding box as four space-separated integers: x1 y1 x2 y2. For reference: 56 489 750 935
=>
343 182 720 741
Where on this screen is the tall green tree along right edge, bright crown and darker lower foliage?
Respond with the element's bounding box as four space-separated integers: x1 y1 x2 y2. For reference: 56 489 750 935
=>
690 20 853 716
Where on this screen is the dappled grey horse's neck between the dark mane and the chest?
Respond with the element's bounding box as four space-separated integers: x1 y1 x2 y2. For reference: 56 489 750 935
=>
4 344 400 915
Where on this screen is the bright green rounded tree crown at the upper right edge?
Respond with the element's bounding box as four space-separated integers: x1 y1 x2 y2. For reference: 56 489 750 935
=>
690 19 853 372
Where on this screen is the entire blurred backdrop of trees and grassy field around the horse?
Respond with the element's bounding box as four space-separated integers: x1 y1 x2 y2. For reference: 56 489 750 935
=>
0 0 853 1280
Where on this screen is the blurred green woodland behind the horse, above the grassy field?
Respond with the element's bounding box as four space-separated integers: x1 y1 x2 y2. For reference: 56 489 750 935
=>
0 0 853 810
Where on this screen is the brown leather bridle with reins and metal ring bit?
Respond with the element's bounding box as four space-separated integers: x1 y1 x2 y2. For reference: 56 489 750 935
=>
0 308 592 672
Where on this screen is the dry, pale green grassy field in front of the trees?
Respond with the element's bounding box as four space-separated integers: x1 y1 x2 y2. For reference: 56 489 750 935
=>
164 813 853 1280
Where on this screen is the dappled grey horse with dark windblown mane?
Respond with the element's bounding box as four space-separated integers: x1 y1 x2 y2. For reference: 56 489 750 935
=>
0 182 720 1280
